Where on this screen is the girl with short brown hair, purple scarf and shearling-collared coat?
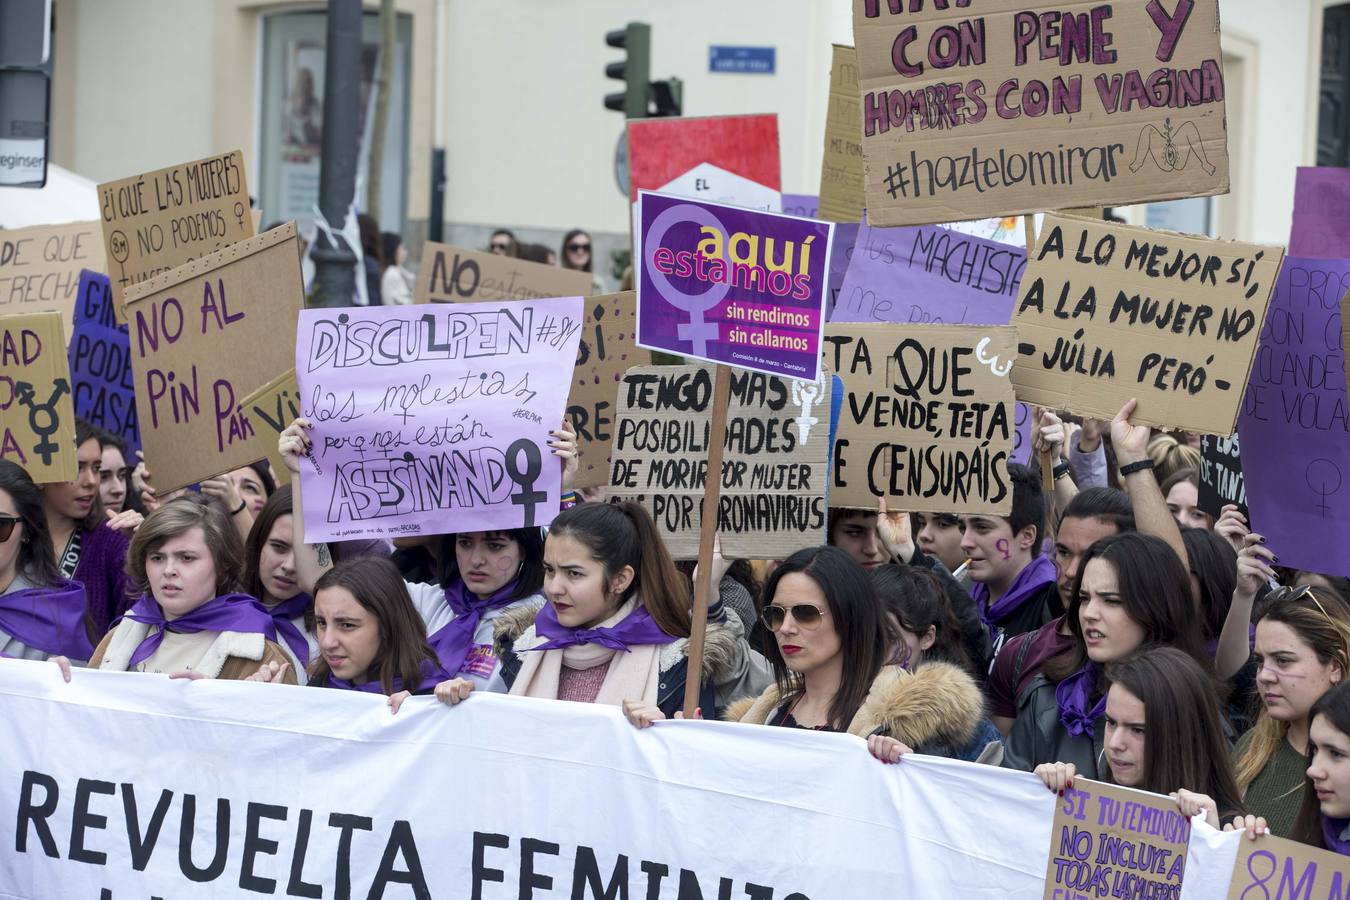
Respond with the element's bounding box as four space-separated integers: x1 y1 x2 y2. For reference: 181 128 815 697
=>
89 495 294 683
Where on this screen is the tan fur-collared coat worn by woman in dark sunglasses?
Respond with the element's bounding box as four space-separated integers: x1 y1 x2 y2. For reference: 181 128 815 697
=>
724 661 1003 765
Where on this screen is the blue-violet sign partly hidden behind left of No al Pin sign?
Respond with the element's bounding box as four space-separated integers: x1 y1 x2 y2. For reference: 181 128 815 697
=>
69 269 140 453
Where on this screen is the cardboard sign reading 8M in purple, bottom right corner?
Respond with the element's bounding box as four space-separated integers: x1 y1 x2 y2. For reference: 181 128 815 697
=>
1224 834 1350 900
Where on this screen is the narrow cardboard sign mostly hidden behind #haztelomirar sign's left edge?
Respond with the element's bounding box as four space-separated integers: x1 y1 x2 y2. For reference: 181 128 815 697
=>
817 43 864 221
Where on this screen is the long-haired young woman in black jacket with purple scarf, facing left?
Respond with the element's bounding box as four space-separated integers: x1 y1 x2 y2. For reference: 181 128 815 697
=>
1004 533 1214 779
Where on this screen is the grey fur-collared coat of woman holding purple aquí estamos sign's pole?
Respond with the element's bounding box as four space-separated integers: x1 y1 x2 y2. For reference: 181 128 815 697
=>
494 602 774 718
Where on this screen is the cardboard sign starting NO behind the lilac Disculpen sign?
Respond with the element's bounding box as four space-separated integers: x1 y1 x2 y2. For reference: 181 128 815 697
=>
413 242 594 304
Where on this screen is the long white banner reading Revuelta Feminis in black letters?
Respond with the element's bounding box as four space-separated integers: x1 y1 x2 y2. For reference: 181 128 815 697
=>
0 660 1237 900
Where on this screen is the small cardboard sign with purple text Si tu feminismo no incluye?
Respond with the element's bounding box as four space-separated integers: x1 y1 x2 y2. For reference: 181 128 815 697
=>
1045 779 1191 900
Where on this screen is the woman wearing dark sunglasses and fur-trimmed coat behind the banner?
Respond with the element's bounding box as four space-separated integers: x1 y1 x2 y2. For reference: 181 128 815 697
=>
707 546 1003 764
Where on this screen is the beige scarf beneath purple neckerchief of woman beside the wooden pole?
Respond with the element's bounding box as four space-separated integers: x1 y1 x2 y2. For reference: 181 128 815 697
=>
510 598 662 706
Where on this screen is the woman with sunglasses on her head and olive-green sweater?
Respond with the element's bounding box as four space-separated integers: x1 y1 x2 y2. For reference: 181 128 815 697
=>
1223 550 1350 838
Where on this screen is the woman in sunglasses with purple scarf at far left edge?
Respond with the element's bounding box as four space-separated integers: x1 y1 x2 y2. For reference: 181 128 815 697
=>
0 460 96 663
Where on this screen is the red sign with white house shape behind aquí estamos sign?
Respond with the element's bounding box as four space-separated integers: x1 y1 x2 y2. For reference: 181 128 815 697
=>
628 115 782 203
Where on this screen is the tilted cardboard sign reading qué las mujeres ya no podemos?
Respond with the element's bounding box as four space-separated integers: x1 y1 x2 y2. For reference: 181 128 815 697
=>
99 150 257 322
